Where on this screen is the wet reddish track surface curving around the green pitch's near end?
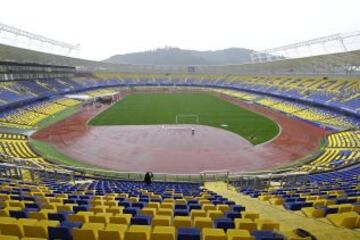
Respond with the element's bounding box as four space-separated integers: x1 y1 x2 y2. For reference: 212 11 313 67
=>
32 95 326 173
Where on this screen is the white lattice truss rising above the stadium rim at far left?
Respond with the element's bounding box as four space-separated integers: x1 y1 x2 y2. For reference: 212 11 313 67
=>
0 23 80 56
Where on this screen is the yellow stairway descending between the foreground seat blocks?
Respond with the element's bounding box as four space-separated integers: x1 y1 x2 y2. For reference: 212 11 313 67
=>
205 182 360 240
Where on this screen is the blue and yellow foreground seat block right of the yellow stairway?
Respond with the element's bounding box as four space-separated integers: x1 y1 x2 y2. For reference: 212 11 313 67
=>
233 164 360 229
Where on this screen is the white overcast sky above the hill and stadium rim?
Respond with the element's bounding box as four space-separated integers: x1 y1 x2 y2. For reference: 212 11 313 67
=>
0 0 360 60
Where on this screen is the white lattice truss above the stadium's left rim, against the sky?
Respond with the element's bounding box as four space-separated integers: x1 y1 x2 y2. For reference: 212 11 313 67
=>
0 23 80 56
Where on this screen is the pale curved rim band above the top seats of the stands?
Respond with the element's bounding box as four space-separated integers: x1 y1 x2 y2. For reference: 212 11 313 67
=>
0 44 360 75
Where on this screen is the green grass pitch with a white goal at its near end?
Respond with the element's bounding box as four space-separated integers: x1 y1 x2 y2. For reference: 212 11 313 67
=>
89 93 279 144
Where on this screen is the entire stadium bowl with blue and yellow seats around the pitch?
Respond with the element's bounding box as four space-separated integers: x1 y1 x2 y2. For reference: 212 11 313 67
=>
0 1 360 240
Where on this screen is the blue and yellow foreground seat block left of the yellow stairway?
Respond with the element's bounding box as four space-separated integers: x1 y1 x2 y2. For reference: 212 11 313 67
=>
0 179 310 240
